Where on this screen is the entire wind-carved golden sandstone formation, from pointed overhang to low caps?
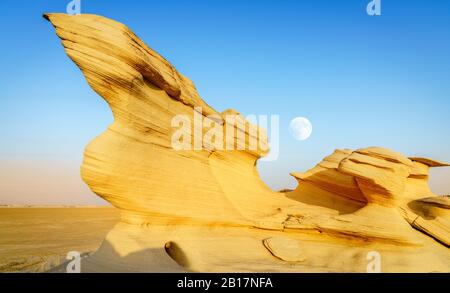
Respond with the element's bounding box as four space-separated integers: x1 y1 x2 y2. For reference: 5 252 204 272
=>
45 14 450 272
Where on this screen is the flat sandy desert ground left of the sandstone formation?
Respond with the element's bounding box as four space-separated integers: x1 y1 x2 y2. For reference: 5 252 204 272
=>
0 207 119 272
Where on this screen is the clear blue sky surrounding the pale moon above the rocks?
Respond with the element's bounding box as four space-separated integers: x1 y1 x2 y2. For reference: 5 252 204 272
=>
0 0 450 203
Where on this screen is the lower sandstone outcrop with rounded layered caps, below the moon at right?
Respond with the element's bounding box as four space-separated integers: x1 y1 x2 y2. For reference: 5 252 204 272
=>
288 147 450 246
